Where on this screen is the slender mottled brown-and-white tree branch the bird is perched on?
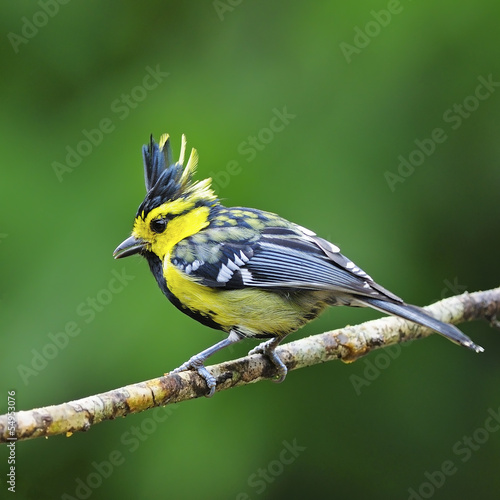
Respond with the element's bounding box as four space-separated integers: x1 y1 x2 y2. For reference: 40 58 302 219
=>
0 287 500 443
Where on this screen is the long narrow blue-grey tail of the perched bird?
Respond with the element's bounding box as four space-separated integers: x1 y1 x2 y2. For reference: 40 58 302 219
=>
358 297 484 352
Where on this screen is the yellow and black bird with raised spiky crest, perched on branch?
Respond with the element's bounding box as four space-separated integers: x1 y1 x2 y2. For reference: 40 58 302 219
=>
113 134 483 397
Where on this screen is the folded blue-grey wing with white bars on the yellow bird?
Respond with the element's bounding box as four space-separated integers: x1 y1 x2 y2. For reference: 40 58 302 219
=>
171 224 402 302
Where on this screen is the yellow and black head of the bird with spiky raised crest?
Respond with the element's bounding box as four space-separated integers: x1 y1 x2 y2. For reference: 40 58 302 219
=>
113 134 217 259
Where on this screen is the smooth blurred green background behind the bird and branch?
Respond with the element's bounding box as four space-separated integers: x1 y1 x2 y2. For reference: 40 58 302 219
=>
0 0 500 500
